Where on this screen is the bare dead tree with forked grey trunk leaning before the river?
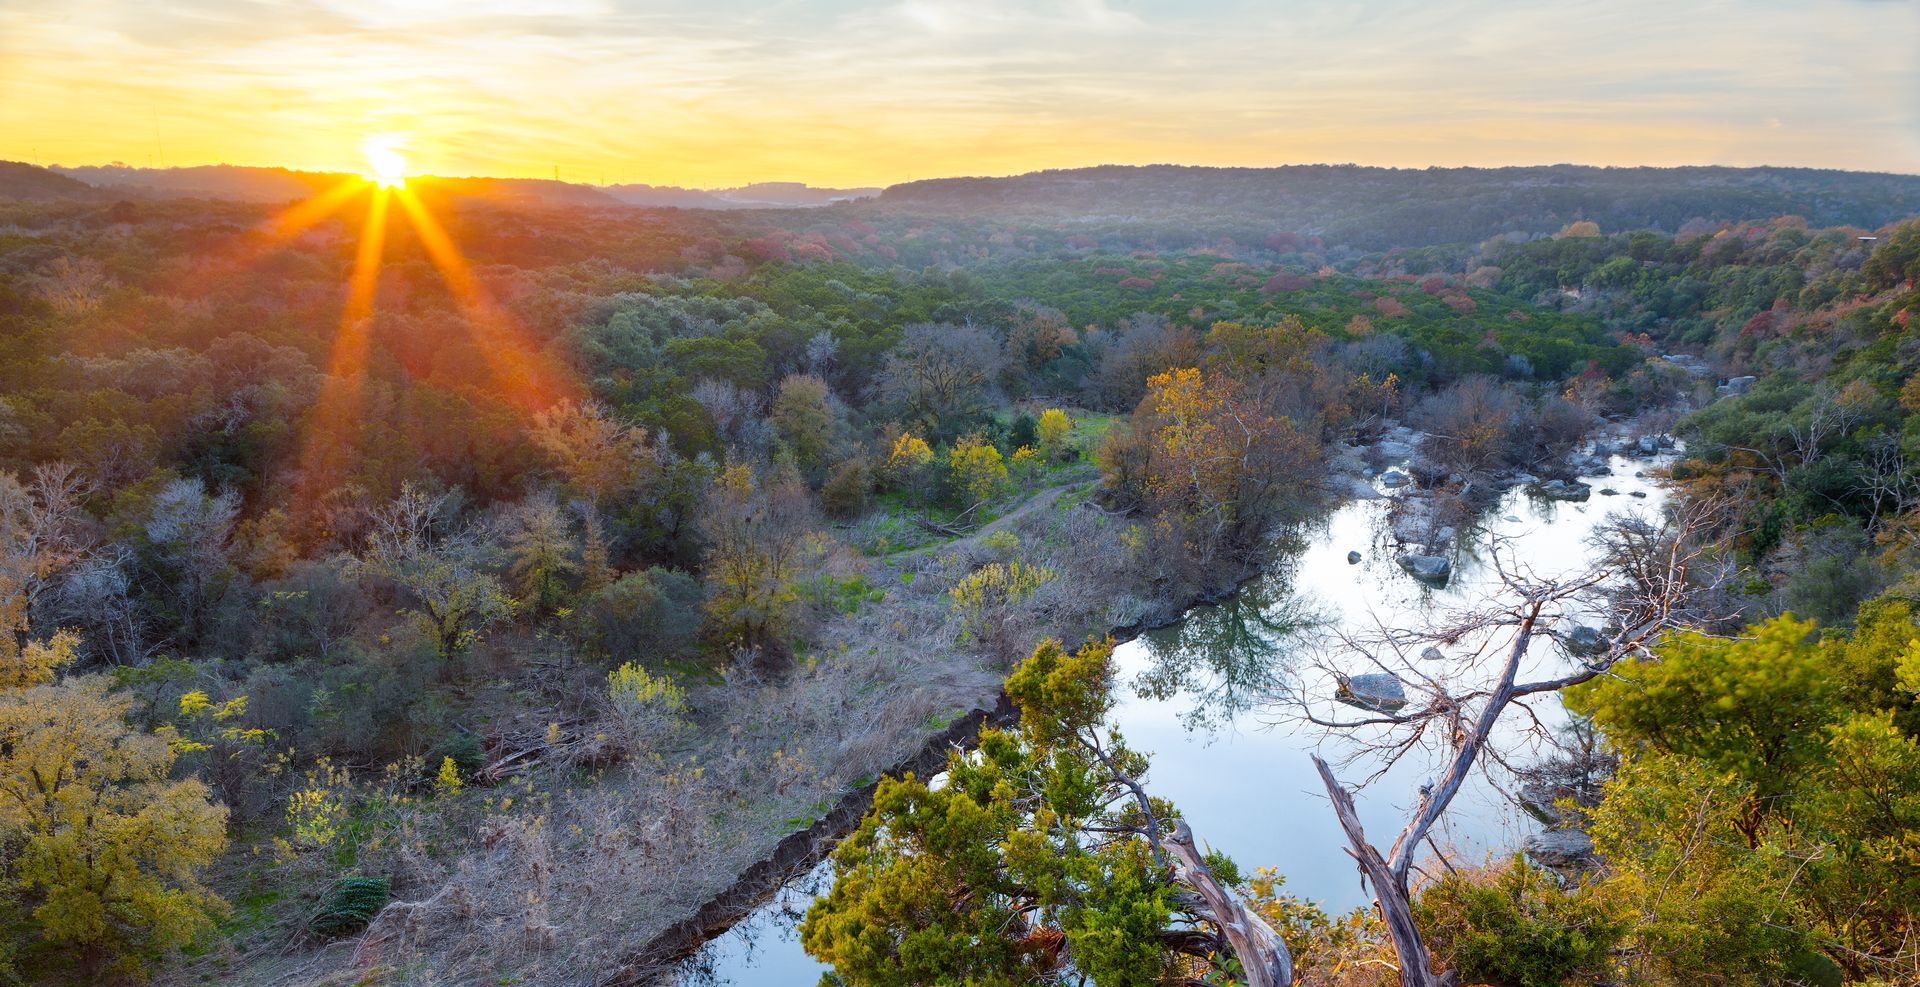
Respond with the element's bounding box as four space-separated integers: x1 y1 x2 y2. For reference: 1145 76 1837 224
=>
1279 507 1711 987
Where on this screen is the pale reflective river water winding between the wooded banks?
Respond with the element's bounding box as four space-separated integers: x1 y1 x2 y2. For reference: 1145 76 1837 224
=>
682 449 1665 987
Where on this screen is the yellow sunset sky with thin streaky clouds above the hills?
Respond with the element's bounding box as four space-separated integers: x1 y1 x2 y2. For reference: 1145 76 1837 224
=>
0 0 1920 188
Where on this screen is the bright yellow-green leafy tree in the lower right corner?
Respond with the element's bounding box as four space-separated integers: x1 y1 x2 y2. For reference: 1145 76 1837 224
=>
1571 605 1920 983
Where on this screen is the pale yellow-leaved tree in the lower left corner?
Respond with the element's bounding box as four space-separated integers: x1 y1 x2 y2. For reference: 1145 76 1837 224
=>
0 632 227 977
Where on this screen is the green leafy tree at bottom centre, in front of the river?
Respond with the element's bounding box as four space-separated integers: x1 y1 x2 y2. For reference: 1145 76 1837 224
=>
801 641 1290 987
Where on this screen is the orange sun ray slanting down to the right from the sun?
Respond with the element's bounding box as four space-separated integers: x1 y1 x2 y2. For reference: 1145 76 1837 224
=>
394 188 578 411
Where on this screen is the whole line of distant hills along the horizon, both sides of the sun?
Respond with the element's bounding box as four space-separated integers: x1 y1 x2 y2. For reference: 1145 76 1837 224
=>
30 165 1920 252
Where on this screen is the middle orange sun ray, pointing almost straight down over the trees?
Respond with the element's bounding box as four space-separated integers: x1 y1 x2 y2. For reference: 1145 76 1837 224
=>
300 188 392 505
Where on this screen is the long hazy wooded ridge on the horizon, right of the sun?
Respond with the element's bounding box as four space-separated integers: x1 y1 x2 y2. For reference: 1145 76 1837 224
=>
862 165 1920 250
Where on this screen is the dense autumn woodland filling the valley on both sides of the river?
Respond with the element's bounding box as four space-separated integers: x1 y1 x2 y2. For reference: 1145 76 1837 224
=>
0 165 1920 975
